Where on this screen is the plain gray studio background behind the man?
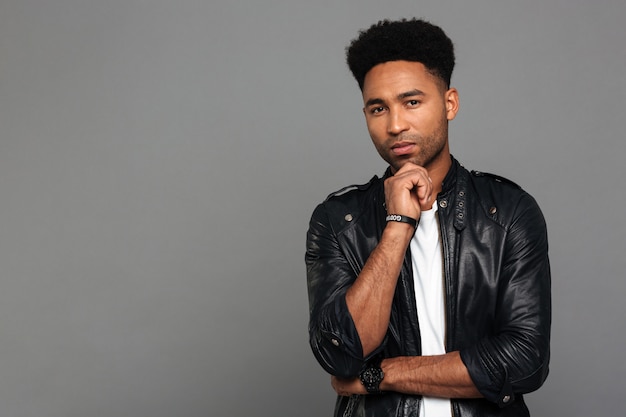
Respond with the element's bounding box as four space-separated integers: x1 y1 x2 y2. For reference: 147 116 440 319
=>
0 0 626 417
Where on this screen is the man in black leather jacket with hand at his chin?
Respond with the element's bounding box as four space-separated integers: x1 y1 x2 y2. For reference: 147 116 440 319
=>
306 19 551 417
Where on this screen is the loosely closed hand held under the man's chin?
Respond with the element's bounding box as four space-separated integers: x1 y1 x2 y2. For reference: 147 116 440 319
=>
385 162 433 219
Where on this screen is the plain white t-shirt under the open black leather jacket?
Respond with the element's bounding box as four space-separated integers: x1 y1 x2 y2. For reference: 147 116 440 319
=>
411 201 452 417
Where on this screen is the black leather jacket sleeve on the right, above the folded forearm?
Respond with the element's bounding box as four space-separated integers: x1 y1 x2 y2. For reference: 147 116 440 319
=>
460 194 551 407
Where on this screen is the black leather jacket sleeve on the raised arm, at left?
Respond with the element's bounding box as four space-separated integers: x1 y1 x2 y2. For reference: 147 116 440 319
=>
305 204 377 377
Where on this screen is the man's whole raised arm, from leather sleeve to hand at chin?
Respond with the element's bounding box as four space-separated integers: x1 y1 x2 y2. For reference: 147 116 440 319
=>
306 164 432 377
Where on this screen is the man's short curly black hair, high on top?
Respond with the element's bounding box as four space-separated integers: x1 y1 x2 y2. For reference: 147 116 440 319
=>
346 19 454 90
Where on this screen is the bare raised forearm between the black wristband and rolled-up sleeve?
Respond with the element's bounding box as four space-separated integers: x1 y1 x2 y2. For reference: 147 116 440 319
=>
346 223 414 356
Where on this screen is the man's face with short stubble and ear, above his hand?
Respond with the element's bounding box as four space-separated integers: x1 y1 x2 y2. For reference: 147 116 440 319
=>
363 61 459 173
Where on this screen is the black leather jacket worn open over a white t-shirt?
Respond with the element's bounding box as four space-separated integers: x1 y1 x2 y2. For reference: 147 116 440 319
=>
305 159 551 417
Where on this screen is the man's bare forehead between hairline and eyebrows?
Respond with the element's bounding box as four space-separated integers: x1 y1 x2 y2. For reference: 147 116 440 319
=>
363 61 442 101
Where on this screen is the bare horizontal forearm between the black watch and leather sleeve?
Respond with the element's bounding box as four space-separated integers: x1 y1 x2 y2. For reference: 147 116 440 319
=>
380 352 482 398
